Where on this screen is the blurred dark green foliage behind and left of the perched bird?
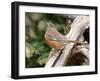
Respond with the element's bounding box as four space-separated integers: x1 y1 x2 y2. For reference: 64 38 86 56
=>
25 12 73 68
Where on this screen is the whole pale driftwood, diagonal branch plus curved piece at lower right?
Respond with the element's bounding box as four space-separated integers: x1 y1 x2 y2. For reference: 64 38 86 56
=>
45 16 89 67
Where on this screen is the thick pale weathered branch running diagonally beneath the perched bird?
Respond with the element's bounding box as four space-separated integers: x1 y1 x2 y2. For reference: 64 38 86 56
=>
45 16 89 67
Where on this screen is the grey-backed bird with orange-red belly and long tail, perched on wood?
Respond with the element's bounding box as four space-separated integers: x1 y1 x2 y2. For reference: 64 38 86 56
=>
44 23 85 50
